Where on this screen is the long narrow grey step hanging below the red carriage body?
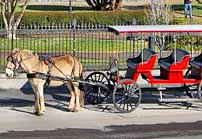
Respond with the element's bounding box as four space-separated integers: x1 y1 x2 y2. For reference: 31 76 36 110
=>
158 98 199 103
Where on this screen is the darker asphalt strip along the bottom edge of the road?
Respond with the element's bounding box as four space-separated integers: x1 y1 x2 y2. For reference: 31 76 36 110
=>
0 122 202 139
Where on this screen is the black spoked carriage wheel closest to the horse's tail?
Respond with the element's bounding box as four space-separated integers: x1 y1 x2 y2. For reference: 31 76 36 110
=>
85 72 110 104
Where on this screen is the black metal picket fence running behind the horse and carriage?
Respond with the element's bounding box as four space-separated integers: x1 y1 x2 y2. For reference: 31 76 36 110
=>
0 24 202 71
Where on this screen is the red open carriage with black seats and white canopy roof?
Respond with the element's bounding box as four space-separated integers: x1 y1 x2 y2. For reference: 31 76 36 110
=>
85 25 202 112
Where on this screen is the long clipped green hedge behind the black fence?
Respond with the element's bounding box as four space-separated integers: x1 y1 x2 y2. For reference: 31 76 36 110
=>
0 10 145 24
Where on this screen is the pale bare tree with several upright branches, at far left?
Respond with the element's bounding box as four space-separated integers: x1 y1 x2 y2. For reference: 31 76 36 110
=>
0 0 30 39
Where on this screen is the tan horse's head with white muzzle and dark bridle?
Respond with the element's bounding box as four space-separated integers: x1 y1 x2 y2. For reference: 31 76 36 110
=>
5 49 22 77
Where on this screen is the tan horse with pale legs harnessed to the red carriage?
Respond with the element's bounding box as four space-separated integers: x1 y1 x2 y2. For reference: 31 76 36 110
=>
6 49 84 116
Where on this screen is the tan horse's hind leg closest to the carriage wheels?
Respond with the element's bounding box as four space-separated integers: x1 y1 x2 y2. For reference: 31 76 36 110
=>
73 82 80 112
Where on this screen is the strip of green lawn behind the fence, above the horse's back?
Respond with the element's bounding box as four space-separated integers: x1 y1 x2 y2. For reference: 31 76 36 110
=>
0 37 148 52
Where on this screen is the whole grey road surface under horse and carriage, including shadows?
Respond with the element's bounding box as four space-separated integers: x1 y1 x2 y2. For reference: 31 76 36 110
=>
0 88 202 139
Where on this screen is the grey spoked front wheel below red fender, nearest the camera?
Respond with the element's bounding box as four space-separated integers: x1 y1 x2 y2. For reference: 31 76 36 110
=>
113 80 142 113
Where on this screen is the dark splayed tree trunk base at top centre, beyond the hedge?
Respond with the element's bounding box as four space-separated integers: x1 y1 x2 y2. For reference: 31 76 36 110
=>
86 0 123 11
